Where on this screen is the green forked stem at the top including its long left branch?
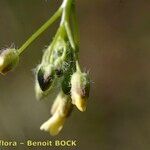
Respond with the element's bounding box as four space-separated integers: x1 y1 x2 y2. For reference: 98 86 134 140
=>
18 0 78 58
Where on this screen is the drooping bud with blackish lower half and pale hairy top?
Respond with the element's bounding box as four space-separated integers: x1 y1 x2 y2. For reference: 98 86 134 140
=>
37 65 55 91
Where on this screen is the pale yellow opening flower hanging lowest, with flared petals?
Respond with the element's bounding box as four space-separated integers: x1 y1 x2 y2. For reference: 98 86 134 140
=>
40 92 72 136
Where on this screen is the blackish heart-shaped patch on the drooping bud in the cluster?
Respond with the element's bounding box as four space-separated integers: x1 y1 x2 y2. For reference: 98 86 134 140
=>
37 68 54 91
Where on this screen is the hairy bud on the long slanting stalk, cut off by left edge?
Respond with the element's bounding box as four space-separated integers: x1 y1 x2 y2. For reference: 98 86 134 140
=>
0 48 19 74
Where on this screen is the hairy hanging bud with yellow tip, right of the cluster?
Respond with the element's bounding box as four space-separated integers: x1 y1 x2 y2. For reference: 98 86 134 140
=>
71 71 90 111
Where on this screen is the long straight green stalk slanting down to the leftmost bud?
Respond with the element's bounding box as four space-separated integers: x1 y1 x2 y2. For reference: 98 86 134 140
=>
18 7 62 54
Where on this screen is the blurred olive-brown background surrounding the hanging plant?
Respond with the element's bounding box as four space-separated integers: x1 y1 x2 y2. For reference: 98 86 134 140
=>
0 0 150 150
